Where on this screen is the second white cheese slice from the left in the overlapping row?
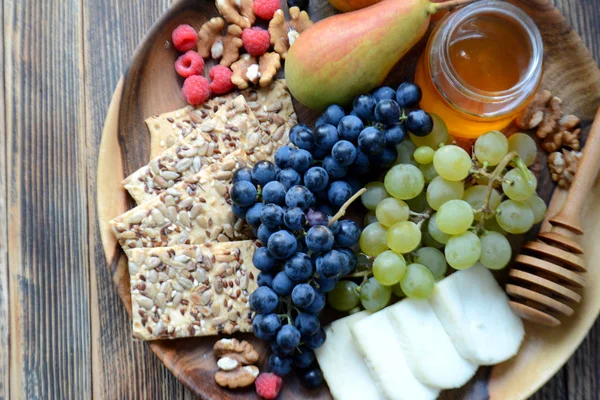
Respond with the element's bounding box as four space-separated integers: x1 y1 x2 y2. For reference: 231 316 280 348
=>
350 309 440 400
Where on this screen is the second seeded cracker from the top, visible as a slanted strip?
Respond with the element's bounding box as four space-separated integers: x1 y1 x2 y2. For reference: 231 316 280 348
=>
123 96 261 204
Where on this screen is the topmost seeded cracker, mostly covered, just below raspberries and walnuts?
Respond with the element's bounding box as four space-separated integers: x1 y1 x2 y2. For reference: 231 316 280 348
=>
146 79 296 158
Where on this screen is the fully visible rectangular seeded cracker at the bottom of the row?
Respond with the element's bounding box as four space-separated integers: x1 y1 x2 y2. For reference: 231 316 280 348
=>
126 240 259 340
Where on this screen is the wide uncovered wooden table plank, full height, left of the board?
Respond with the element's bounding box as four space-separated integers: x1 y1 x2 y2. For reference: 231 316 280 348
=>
0 0 92 399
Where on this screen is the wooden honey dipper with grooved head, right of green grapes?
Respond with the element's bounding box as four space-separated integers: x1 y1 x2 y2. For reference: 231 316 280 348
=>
506 108 600 326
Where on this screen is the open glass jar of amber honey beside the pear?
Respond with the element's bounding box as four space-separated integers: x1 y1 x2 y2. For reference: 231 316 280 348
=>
415 0 543 138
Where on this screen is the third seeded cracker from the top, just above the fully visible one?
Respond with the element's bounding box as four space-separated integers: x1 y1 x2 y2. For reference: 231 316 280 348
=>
110 150 252 250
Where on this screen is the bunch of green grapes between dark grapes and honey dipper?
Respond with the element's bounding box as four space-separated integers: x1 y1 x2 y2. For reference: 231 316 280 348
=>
357 126 546 311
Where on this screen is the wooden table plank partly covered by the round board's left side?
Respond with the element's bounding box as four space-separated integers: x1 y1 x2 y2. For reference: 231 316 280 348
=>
83 0 194 399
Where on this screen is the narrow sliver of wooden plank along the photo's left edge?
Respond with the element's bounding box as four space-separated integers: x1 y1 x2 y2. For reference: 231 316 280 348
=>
0 0 10 399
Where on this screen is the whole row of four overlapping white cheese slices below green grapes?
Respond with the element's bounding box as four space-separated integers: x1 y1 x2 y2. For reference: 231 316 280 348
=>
317 264 524 400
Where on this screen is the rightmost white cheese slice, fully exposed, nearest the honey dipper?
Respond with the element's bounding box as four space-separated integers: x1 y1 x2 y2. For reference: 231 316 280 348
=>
429 263 525 365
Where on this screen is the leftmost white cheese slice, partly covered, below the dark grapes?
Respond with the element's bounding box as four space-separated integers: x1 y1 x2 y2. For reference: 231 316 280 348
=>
315 311 385 400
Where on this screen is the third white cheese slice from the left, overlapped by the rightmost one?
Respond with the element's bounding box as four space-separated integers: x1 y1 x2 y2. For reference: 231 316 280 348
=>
387 299 478 389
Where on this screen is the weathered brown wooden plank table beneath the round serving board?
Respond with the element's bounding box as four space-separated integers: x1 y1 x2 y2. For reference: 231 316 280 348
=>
0 0 600 400
